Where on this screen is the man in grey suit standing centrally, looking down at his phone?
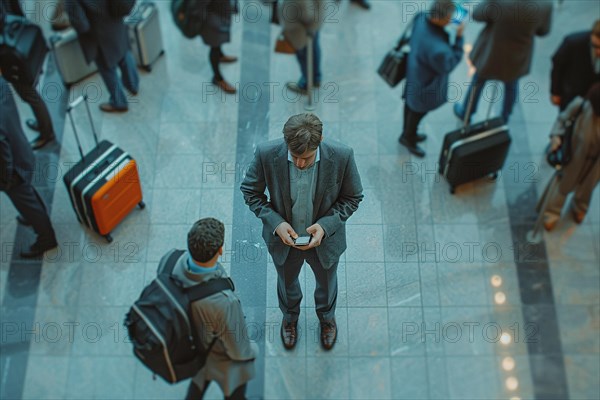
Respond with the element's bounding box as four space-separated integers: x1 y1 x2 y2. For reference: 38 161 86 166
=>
241 114 363 350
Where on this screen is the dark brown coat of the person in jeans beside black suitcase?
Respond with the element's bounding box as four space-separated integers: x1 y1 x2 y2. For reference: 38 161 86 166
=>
470 0 553 82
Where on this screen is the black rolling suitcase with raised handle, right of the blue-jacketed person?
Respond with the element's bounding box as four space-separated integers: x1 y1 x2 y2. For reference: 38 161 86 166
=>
439 83 511 193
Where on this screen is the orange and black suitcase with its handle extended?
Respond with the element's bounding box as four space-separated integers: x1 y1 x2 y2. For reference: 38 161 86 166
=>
63 97 145 242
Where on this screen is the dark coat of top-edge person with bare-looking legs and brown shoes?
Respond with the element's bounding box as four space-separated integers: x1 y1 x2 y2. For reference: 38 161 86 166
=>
199 0 237 47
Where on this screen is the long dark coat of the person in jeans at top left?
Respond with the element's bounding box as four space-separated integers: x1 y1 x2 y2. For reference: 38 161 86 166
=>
65 0 129 68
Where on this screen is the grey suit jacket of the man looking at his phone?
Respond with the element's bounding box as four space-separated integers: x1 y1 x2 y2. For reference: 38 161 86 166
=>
241 139 364 268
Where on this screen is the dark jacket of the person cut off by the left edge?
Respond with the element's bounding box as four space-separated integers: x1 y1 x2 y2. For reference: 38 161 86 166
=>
0 76 35 188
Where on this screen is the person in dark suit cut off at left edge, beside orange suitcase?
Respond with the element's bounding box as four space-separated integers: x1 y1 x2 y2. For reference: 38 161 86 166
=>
0 76 58 258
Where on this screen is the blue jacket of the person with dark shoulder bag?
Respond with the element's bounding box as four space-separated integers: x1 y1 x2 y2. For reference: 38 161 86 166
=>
404 13 463 113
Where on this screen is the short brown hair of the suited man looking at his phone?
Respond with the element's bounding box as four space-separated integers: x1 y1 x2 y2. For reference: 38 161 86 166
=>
283 113 323 155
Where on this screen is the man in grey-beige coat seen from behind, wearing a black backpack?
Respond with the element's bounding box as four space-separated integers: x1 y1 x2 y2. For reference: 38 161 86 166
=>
158 218 258 400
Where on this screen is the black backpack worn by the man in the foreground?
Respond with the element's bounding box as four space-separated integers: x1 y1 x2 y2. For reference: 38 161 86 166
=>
125 250 234 383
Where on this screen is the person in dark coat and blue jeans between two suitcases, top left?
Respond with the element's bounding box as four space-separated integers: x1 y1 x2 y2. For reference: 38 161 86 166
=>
65 0 139 112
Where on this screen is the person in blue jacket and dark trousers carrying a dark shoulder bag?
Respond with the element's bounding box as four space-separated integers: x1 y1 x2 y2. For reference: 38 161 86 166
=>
398 0 464 157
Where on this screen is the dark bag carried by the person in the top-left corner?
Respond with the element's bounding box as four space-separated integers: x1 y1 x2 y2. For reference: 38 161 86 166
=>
0 14 48 87
